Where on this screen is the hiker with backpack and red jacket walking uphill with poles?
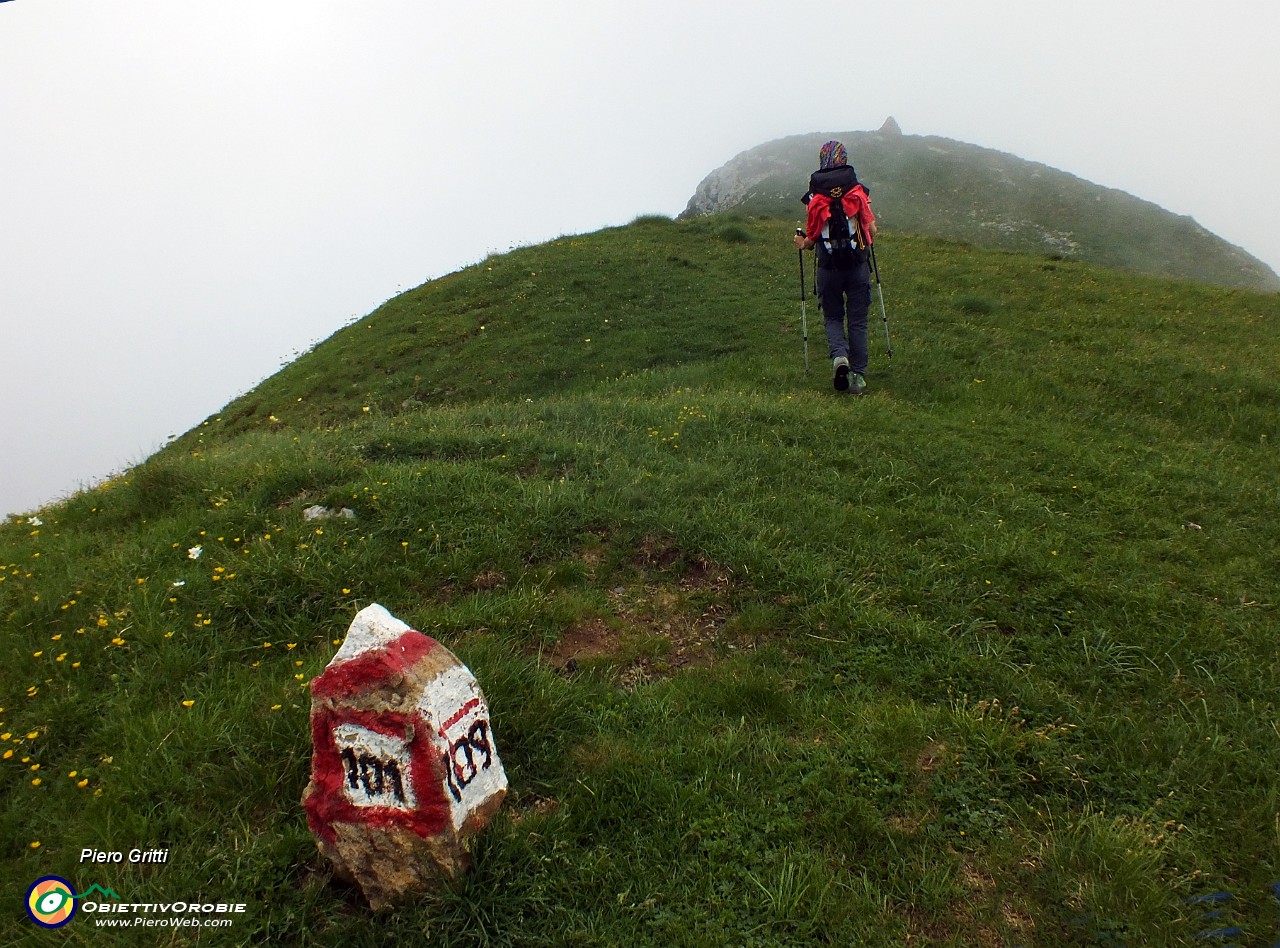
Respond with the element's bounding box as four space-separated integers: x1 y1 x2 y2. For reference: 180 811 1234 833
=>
795 142 876 395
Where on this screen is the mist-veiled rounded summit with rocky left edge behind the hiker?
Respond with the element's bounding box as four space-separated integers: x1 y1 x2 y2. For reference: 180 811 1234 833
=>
684 118 1280 292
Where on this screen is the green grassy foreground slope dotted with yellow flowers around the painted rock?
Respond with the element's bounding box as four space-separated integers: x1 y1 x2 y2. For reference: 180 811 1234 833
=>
0 217 1280 945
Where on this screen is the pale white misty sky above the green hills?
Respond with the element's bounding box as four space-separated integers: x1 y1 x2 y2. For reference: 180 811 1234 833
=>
0 0 1280 516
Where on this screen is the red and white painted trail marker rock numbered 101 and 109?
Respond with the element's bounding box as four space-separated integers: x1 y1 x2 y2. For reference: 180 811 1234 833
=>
302 605 507 908
